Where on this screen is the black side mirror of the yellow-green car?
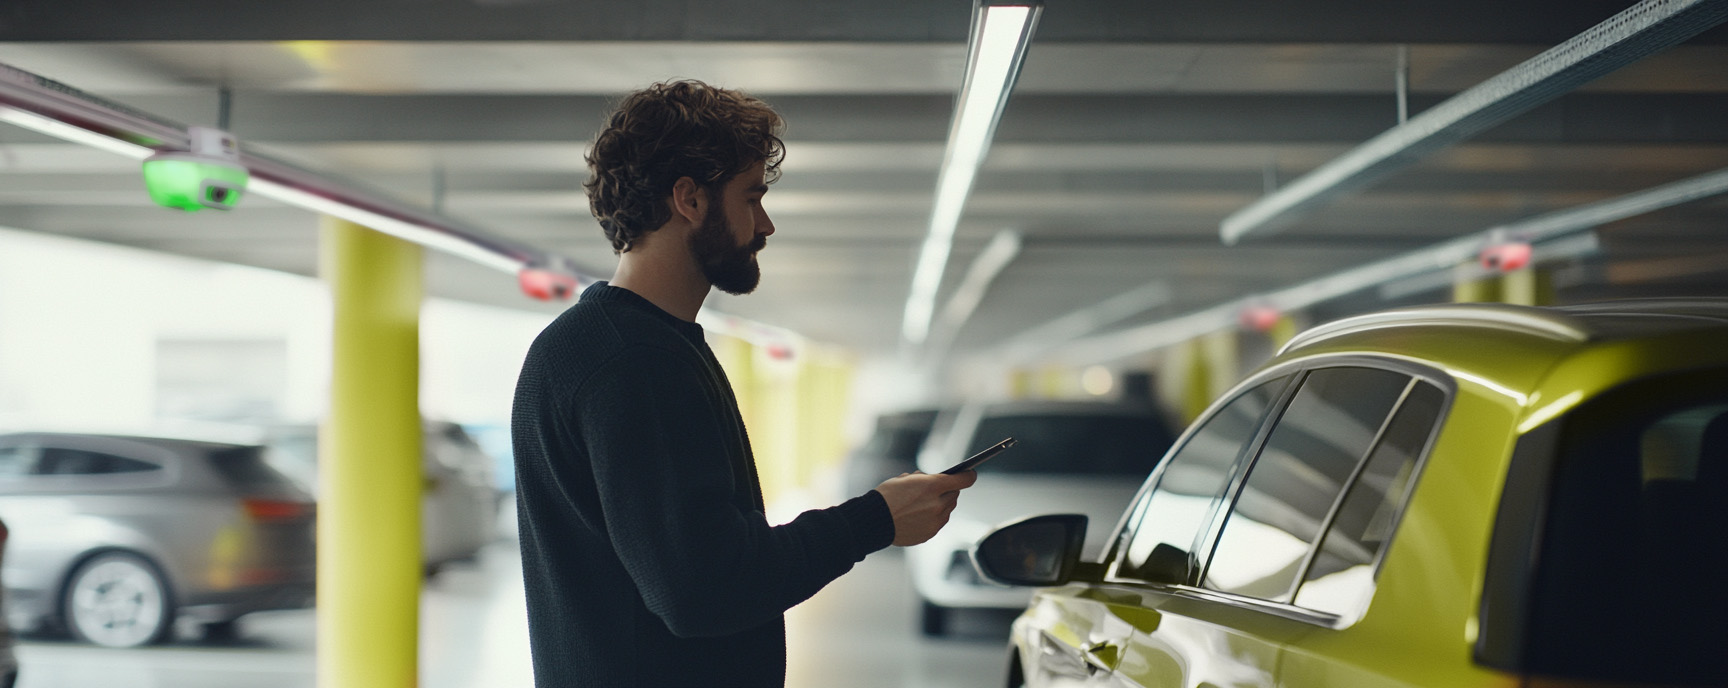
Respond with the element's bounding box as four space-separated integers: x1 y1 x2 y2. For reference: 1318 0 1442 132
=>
973 513 1087 586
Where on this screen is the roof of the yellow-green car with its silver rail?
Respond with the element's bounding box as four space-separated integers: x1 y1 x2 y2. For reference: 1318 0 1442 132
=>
1279 297 1728 356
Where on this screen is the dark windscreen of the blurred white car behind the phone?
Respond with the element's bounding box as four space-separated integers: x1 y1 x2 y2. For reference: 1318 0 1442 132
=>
966 415 1172 479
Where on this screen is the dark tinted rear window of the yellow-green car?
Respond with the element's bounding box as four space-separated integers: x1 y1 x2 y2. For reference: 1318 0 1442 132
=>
1515 364 1728 686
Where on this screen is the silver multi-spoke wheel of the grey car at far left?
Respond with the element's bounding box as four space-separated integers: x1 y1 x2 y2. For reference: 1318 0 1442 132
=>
64 551 175 648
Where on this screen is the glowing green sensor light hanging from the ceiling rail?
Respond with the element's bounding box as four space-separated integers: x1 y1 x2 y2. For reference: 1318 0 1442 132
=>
143 126 251 213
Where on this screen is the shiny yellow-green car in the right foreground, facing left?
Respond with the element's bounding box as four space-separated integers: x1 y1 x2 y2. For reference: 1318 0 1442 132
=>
973 299 1728 688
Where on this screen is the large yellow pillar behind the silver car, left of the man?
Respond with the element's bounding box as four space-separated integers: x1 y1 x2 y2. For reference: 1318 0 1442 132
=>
316 218 425 688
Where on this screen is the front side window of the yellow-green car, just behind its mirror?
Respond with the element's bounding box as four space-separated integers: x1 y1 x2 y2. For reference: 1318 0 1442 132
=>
1116 375 1289 583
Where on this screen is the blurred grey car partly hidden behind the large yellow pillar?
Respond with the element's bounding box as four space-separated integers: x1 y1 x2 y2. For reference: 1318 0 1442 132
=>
264 420 503 574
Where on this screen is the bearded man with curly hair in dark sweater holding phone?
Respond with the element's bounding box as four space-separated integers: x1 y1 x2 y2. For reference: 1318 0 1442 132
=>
511 81 976 688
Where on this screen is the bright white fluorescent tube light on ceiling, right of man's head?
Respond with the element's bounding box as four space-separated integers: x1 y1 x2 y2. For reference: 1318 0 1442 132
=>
900 3 1042 344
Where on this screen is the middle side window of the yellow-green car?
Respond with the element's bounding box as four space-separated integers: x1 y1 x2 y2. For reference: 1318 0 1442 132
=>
1201 366 1410 602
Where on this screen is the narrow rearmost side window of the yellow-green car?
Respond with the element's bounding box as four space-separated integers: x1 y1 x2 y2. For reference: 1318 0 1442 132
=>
1296 382 1446 619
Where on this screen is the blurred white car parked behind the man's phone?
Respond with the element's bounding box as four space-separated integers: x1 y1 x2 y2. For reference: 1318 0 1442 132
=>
905 399 1173 636
